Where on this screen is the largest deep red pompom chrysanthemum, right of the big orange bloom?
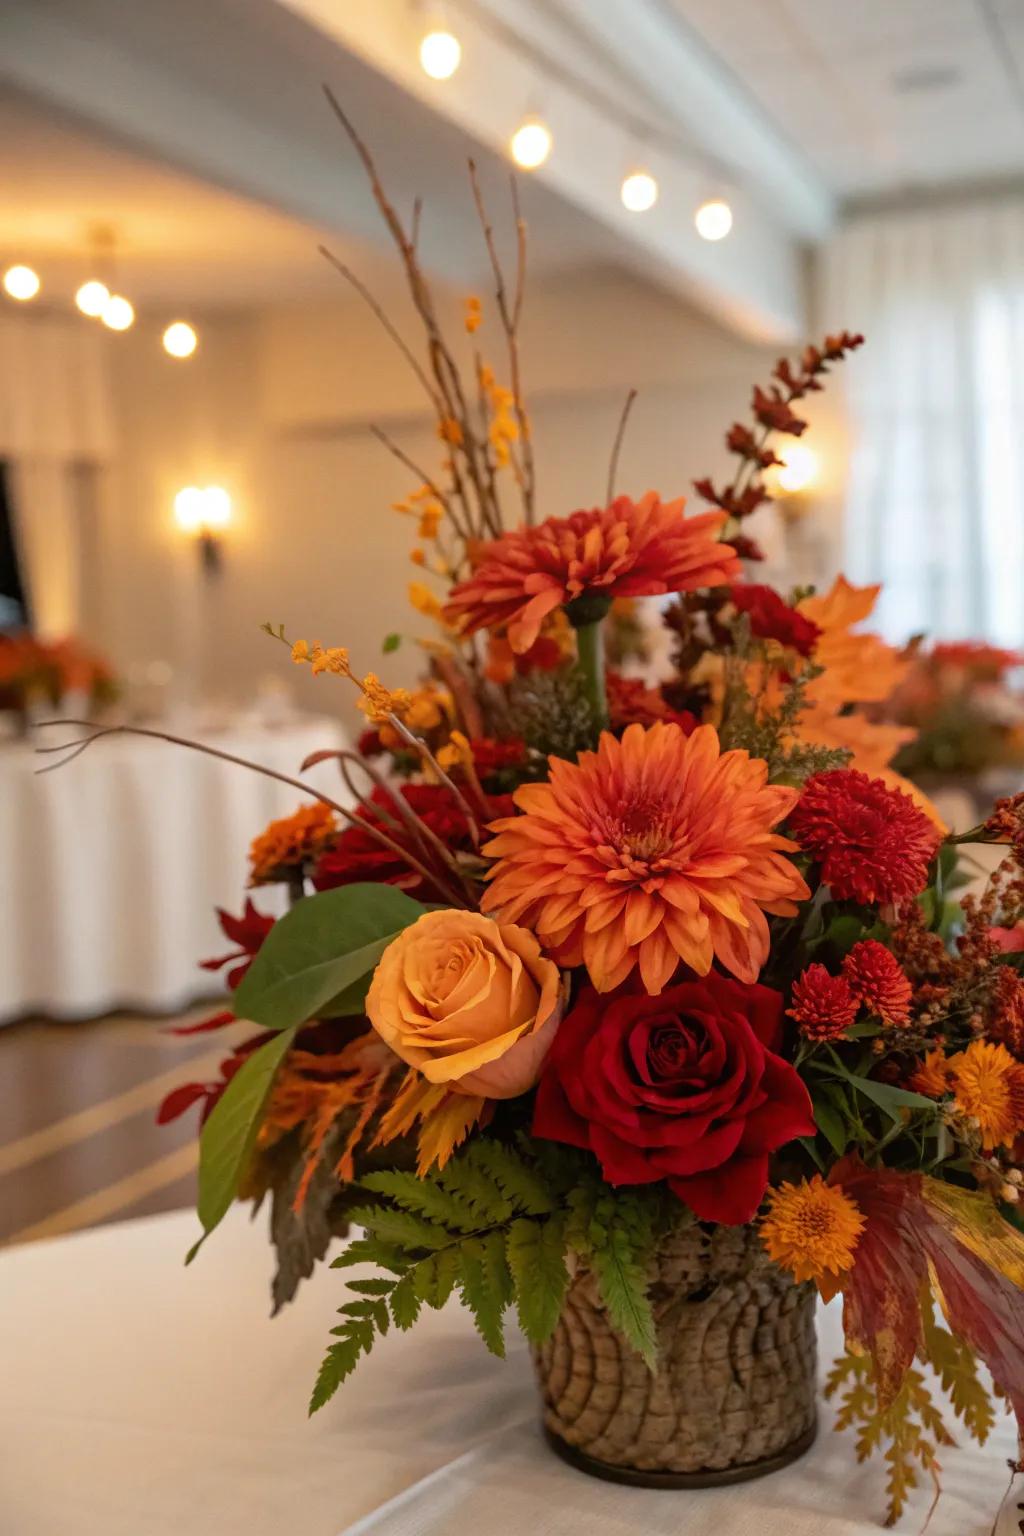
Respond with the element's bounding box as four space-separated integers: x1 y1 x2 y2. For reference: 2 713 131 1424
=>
789 768 940 906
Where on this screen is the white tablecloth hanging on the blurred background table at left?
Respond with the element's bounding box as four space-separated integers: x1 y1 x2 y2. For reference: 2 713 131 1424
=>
0 716 345 1026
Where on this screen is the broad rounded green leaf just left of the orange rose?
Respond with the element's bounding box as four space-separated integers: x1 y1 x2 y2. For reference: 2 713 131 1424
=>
232 885 425 1029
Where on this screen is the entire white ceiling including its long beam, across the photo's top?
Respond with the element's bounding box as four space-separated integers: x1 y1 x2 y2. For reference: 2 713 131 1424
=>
0 0 1024 331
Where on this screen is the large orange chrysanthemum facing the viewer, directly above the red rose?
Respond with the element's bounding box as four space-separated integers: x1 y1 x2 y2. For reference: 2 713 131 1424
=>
484 722 809 992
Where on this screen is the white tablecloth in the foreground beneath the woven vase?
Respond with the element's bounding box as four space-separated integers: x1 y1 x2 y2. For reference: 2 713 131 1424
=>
0 1209 1024 1536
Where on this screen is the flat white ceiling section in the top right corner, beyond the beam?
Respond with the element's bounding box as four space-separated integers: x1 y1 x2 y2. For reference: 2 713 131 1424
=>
663 0 1024 198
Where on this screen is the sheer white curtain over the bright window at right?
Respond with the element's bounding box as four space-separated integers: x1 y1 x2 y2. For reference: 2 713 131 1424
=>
821 197 1024 645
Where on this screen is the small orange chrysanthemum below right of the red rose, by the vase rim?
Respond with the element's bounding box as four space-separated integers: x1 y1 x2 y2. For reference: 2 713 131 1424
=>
761 1174 864 1290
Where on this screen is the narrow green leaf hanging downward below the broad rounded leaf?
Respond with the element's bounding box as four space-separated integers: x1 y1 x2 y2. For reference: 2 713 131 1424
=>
189 1029 295 1258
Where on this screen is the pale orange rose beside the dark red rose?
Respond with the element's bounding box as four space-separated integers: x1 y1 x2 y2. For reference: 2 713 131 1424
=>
367 909 563 1098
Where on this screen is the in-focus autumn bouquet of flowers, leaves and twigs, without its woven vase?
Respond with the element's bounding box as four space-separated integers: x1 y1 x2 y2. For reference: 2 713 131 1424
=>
49 108 1024 1521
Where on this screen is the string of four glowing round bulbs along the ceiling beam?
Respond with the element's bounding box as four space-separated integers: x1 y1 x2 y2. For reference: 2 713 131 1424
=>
419 12 732 241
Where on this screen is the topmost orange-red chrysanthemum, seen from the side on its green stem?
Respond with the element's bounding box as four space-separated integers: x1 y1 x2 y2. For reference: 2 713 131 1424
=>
444 492 742 653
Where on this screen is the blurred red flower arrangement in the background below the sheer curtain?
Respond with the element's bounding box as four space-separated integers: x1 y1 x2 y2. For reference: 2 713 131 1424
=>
878 641 1024 783
